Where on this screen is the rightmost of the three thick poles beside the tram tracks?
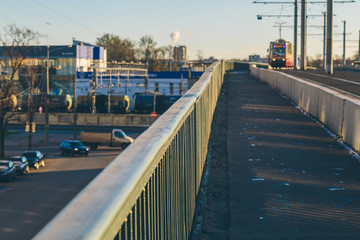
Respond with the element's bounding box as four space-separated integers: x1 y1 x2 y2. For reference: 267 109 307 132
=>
326 0 334 74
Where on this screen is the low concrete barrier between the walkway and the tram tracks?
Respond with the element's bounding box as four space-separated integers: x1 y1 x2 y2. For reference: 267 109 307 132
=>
250 66 360 151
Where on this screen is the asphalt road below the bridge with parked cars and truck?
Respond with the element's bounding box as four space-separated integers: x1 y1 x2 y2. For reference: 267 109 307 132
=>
0 126 140 239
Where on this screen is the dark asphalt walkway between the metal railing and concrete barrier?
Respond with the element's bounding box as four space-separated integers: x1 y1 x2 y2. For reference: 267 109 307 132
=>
203 73 360 240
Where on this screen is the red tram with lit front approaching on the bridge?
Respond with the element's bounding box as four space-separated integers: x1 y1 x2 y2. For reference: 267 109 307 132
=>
268 39 294 68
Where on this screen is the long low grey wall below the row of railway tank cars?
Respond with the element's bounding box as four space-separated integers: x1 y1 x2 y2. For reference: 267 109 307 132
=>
5 113 155 127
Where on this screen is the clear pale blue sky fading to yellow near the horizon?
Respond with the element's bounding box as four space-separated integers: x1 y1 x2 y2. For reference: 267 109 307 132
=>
0 0 360 59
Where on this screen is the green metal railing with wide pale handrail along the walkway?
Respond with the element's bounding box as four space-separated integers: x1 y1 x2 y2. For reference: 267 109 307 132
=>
35 61 242 240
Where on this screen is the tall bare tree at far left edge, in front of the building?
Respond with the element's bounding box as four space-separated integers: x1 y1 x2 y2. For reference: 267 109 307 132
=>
0 24 40 157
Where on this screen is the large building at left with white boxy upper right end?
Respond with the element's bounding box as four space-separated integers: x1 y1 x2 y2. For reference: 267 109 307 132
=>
0 41 106 96
